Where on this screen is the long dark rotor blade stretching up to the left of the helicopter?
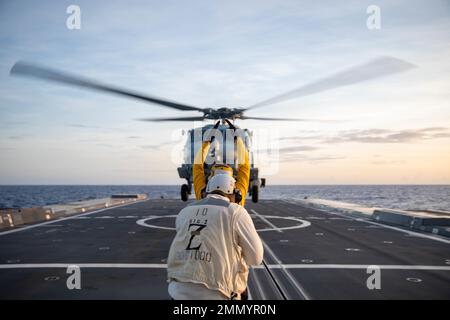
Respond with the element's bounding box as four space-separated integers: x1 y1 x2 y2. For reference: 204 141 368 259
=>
10 61 203 112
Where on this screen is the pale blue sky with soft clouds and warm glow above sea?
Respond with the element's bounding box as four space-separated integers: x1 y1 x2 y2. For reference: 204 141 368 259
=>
0 0 450 184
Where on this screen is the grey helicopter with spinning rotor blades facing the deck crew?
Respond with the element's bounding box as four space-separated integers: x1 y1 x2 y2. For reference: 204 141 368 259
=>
10 56 415 202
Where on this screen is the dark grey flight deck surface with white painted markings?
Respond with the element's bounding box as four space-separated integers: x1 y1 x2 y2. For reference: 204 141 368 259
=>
0 200 450 299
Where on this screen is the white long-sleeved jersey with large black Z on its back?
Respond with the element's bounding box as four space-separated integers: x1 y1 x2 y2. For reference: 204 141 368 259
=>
167 194 263 299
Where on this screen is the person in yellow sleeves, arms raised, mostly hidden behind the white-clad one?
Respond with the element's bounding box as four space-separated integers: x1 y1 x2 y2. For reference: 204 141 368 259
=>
193 124 250 206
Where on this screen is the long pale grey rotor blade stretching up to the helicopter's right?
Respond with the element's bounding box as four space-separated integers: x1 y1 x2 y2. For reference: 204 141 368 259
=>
245 57 416 110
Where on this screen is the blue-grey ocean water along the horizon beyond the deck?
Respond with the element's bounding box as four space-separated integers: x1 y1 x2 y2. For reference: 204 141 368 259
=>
0 185 450 211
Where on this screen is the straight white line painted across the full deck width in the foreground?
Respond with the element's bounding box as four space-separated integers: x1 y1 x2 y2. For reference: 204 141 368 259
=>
0 263 450 272
